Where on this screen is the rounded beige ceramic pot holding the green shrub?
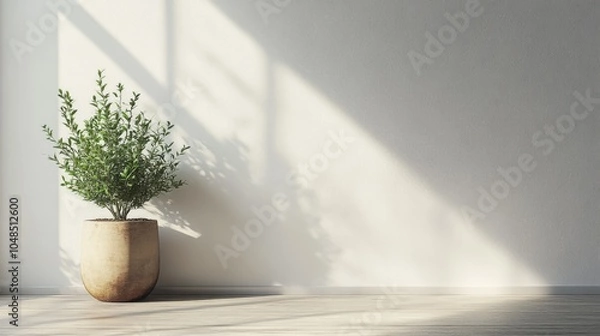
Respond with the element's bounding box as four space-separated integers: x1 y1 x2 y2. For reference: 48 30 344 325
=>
81 220 160 302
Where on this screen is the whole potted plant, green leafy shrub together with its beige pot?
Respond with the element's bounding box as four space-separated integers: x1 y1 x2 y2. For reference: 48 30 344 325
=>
43 70 190 301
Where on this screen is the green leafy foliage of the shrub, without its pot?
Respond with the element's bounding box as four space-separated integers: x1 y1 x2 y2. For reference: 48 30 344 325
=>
42 70 190 220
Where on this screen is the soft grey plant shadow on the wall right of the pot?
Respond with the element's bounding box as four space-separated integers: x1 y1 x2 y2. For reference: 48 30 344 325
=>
148 134 335 287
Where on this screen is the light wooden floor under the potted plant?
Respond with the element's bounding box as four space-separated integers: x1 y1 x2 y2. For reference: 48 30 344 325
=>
0 294 600 336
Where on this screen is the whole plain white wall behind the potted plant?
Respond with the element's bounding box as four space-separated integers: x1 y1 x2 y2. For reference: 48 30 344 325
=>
0 0 600 292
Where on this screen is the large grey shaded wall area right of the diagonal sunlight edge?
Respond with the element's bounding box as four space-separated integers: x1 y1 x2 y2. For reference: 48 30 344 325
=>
209 1 600 285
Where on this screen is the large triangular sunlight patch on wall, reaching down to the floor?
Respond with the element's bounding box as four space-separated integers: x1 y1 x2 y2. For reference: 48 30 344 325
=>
276 61 544 287
